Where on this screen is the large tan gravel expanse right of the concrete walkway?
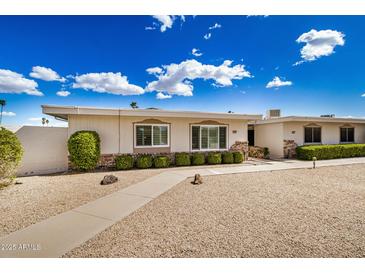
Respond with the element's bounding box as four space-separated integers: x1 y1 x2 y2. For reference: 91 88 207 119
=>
65 165 365 257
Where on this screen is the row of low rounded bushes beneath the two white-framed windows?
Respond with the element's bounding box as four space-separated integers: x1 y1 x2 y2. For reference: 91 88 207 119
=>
115 152 243 170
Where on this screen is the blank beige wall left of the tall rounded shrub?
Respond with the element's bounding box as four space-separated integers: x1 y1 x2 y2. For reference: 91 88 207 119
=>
16 126 68 176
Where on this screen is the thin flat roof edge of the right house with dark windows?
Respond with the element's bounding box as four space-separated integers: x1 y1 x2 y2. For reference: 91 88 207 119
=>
256 116 365 125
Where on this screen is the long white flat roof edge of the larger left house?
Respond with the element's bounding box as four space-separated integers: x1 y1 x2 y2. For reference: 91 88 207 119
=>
42 105 262 120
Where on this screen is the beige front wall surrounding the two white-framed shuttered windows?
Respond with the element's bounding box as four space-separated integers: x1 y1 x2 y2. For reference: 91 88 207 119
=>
68 115 247 154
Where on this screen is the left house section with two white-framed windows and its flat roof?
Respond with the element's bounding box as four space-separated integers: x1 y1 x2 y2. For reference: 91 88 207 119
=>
42 105 262 165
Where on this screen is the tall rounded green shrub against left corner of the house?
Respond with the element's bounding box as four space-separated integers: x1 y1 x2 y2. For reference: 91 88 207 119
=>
67 130 100 170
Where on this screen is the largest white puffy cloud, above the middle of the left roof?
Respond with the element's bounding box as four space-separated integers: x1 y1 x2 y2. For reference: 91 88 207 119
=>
146 59 252 96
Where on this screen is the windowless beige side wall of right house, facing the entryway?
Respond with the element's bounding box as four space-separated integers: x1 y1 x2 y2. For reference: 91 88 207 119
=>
255 123 284 158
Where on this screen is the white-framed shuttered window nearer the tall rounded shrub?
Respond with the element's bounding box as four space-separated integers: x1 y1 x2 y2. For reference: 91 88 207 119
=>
135 125 169 147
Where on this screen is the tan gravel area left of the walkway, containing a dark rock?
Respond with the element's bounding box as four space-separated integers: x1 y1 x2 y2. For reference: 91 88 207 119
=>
0 169 163 237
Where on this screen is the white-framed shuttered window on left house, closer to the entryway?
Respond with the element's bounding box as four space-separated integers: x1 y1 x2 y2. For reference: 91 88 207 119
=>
191 126 227 150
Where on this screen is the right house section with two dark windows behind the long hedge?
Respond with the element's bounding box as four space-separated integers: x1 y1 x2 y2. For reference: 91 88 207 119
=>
250 116 365 158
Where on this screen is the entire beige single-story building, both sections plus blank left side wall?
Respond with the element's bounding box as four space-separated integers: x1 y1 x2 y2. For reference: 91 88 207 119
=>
9 105 365 175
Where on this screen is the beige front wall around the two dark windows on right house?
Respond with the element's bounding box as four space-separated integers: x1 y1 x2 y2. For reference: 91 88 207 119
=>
284 122 365 145
